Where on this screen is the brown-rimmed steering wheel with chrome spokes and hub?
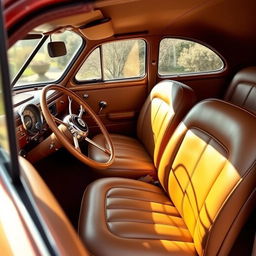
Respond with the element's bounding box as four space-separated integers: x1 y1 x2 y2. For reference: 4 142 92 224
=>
40 85 115 169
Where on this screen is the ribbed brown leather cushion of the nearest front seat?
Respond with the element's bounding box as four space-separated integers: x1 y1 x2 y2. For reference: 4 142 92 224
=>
79 178 196 256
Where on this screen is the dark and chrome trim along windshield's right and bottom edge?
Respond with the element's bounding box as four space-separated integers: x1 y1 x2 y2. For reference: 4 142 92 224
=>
12 32 86 91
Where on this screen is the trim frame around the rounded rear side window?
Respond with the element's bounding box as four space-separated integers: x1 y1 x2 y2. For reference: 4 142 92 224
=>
157 36 227 78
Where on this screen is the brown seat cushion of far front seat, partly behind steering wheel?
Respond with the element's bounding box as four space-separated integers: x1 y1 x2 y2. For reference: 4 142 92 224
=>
88 134 156 178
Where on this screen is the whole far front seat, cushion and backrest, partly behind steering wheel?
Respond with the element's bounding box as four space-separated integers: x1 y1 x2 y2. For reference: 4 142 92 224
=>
89 80 195 178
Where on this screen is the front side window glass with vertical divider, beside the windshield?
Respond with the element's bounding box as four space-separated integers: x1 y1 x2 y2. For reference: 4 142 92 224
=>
75 39 146 82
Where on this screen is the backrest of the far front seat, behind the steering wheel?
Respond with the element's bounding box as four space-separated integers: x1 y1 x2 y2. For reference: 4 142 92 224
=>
137 80 195 166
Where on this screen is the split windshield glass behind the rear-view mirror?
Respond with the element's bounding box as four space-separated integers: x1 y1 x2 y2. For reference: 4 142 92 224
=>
8 31 82 87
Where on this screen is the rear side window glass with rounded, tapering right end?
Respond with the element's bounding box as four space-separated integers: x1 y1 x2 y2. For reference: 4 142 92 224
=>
158 38 224 76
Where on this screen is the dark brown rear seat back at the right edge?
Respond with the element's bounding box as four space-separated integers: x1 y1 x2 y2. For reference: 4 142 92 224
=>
224 67 256 113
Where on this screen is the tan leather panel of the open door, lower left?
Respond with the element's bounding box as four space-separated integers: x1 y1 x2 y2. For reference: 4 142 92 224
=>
19 157 89 256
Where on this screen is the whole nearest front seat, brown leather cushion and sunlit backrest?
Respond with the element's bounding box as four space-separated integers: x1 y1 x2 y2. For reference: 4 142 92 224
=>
79 100 256 256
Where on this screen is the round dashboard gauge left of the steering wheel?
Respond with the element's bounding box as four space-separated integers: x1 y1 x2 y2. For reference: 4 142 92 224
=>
20 104 43 136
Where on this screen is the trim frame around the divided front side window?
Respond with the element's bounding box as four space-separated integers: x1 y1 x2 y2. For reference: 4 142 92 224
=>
73 38 148 85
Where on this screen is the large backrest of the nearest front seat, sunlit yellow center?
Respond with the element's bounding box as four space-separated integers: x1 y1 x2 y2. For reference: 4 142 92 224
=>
158 100 256 256
